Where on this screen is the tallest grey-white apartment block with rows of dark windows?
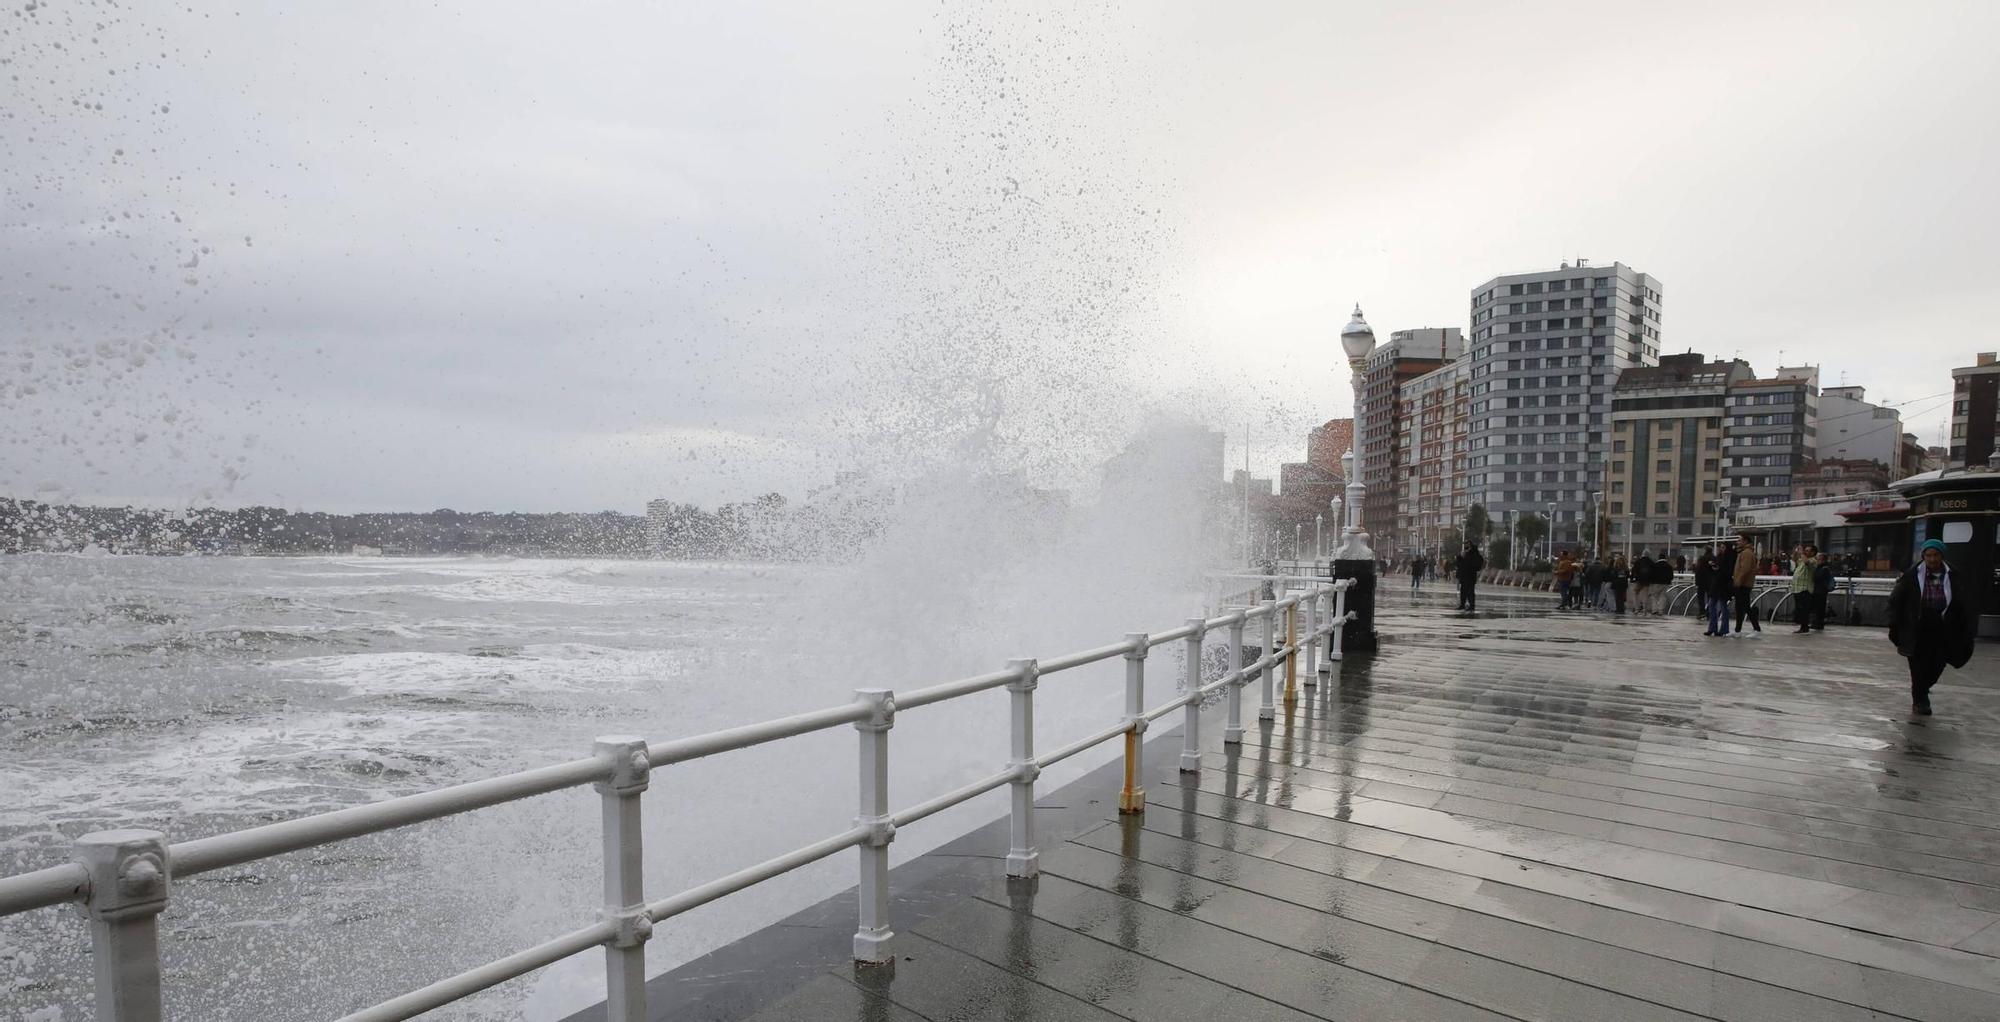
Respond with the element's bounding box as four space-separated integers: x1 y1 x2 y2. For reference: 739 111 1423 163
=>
1470 260 1662 544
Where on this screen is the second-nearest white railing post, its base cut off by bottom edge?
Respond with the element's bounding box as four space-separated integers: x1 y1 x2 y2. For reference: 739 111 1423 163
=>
590 734 652 1022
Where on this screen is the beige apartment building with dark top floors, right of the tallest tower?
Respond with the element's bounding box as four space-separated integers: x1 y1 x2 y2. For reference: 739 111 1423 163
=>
1604 354 1756 552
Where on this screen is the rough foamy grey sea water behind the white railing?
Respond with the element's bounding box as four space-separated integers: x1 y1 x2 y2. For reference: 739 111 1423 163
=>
0 554 1176 1022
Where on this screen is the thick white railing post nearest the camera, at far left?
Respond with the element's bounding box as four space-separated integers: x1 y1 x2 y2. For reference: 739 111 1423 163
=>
70 830 172 1022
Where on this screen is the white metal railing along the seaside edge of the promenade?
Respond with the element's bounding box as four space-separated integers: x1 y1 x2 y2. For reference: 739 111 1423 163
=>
0 576 1352 1022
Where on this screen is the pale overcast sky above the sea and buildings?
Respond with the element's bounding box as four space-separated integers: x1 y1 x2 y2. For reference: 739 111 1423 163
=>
0 0 2000 510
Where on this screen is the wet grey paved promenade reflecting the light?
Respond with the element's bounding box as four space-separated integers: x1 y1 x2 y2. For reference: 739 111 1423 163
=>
600 586 2000 1022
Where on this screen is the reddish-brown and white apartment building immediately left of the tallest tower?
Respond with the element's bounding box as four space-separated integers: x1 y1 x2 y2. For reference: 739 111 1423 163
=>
1394 358 1472 558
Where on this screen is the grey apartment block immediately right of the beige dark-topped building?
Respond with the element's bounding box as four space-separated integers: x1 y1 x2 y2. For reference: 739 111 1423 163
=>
1722 366 1820 508
